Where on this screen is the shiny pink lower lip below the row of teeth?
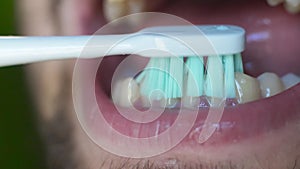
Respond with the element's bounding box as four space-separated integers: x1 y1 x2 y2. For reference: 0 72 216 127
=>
85 56 300 146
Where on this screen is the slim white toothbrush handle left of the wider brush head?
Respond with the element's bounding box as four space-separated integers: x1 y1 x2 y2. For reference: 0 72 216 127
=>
0 35 131 66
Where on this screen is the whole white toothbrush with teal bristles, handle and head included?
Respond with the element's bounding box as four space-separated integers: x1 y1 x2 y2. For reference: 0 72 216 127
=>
0 25 245 100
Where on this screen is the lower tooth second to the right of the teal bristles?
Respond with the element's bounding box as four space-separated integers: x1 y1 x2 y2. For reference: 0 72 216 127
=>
257 72 284 98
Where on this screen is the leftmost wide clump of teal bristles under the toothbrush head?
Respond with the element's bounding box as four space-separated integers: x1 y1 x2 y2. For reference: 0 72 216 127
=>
136 57 184 100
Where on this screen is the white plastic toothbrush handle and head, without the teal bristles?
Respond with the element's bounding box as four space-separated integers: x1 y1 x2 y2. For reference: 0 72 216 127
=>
0 25 245 66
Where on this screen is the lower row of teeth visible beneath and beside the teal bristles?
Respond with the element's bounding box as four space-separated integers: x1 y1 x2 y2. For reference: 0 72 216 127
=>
112 72 300 107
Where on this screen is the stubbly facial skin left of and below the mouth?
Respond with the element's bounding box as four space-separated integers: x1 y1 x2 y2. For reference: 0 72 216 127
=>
17 0 300 169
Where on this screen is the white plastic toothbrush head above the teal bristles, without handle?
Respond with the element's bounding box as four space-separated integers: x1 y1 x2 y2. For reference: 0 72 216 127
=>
133 25 245 57
